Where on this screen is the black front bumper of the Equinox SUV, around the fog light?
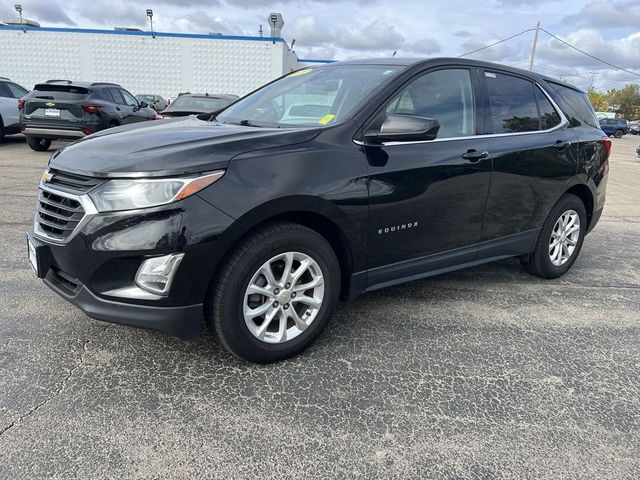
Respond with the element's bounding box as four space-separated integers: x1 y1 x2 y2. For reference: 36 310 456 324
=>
28 189 233 339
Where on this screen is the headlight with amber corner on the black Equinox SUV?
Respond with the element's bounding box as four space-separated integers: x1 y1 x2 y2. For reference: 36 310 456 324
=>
89 170 224 212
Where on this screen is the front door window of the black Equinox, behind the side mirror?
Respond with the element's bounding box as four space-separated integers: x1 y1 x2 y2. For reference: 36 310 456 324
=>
386 68 475 138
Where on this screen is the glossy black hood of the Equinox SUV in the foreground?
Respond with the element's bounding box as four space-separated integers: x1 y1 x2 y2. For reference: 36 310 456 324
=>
49 116 320 177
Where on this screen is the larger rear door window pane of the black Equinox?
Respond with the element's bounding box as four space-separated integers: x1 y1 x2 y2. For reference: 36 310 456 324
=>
485 72 540 133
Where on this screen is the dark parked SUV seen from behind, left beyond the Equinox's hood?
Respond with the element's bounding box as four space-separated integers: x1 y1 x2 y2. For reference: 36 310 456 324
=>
19 80 156 151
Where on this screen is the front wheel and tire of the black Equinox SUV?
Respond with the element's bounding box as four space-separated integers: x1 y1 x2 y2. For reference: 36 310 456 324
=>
205 222 340 363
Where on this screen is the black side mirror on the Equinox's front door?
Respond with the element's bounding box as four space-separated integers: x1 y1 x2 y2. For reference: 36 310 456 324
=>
364 113 440 144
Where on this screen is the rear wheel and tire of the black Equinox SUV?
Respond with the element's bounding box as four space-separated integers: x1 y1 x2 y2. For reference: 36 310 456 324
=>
521 194 587 279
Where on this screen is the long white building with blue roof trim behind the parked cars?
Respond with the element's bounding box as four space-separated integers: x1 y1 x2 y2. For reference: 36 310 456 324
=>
0 25 307 97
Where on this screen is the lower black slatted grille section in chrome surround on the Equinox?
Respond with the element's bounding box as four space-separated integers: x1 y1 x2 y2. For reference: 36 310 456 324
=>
36 190 85 241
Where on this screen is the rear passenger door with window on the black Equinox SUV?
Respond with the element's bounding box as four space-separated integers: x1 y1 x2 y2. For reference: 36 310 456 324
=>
481 70 578 248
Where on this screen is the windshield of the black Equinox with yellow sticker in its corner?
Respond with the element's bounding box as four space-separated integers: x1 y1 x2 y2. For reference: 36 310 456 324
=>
216 65 402 126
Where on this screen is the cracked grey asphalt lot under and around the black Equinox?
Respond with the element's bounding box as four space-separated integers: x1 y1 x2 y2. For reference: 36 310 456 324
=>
0 135 640 480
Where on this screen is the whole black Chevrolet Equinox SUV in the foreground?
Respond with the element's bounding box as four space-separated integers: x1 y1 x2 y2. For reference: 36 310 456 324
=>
28 58 611 362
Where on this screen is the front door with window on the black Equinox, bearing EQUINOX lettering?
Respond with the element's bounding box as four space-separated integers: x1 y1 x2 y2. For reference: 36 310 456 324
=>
365 68 491 286
